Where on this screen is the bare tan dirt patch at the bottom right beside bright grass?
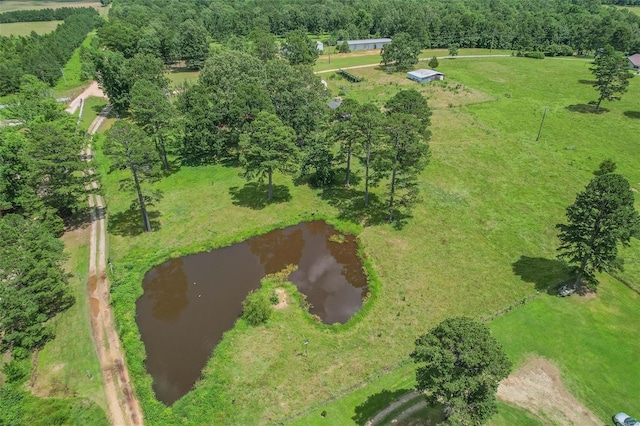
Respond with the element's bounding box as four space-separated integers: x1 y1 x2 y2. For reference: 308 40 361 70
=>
497 357 602 426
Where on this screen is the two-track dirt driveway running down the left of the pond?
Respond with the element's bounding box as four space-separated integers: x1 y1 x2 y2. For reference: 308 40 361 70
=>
85 104 143 426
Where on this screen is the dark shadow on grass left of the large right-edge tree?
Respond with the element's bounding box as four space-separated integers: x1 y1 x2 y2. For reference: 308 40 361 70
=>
511 256 571 294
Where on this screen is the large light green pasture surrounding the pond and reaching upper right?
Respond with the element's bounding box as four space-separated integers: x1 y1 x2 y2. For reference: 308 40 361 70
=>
101 57 640 424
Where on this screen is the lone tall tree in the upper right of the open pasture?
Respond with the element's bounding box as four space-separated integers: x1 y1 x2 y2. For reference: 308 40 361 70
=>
589 46 633 112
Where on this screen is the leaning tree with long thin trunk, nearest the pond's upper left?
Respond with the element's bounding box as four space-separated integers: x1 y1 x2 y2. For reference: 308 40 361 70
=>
104 120 158 232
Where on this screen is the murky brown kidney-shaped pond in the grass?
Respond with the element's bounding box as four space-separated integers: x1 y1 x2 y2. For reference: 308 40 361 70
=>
136 221 367 405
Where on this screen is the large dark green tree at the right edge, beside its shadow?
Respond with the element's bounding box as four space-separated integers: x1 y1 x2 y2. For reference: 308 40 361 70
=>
556 173 640 287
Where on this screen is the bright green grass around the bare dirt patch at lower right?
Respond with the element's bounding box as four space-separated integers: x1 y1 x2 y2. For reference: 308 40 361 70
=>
490 277 640 421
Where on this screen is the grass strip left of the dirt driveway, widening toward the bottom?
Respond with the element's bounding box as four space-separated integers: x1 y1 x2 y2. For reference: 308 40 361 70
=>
32 225 107 416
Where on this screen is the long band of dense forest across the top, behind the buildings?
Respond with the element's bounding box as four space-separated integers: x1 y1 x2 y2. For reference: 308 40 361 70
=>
96 0 640 61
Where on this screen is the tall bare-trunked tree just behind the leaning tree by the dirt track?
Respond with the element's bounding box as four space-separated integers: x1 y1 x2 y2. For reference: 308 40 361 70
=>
130 80 176 170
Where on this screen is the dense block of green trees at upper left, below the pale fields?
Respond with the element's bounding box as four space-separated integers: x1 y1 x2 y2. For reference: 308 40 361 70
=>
0 8 102 96
